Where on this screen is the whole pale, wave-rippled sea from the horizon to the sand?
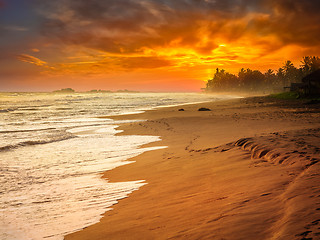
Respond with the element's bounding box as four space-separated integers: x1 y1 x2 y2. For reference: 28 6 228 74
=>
0 93 231 240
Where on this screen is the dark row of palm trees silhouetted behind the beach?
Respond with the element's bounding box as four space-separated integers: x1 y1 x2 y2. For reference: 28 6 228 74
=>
205 56 320 93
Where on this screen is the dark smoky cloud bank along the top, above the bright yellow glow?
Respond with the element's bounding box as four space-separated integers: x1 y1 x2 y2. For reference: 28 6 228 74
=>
35 0 320 54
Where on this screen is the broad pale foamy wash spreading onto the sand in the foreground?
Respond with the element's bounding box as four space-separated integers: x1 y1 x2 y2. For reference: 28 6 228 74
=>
0 125 168 240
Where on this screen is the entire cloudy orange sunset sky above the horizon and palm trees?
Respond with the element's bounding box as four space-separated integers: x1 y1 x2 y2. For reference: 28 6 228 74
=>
0 0 320 92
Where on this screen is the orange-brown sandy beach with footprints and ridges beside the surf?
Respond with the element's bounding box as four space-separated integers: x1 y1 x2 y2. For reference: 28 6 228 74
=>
65 97 320 240
